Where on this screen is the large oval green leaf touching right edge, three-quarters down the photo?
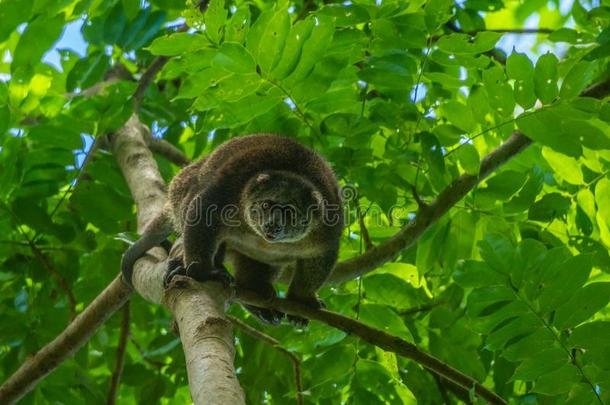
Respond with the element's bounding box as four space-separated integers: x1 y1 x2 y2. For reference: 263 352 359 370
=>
553 283 610 329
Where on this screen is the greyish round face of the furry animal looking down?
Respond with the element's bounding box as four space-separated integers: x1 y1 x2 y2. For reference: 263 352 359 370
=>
244 173 322 243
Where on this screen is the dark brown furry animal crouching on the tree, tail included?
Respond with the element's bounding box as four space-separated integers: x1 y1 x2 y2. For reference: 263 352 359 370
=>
121 134 343 326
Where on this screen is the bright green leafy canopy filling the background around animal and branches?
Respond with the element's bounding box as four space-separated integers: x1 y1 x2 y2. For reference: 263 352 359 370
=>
0 0 610 404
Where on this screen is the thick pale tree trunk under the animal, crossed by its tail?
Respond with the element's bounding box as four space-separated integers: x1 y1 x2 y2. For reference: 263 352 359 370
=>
111 115 245 405
